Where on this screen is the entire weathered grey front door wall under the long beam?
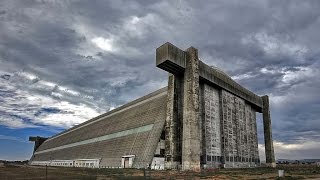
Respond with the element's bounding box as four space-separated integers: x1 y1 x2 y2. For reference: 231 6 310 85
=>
200 86 260 168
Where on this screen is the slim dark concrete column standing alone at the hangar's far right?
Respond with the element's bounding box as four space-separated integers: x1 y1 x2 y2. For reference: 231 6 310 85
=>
262 95 276 167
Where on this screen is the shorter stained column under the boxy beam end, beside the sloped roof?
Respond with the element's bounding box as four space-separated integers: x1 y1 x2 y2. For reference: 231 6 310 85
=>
165 73 182 169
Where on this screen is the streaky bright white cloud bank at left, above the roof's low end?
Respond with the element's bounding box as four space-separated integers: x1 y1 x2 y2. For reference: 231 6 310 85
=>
0 72 103 128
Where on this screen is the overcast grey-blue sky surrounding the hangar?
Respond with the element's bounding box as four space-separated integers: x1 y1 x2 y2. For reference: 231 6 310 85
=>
0 0 320 160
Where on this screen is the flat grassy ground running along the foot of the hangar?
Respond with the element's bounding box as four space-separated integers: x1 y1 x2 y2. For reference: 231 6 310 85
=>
0 165 320 180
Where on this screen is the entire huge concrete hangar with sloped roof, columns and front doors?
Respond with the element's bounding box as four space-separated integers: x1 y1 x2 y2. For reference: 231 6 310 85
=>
29 43 275 171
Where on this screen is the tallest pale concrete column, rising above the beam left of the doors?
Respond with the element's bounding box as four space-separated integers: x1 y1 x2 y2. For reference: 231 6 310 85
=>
182 47 201 171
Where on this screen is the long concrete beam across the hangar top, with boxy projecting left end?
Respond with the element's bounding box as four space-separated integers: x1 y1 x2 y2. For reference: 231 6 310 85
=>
156 42 262 112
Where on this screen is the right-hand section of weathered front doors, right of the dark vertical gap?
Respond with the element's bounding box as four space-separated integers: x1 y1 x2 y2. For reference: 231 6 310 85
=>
222 90 259 167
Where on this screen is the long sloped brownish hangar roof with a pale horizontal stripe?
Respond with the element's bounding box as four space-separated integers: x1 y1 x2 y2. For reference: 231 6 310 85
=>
31 87 167 168
